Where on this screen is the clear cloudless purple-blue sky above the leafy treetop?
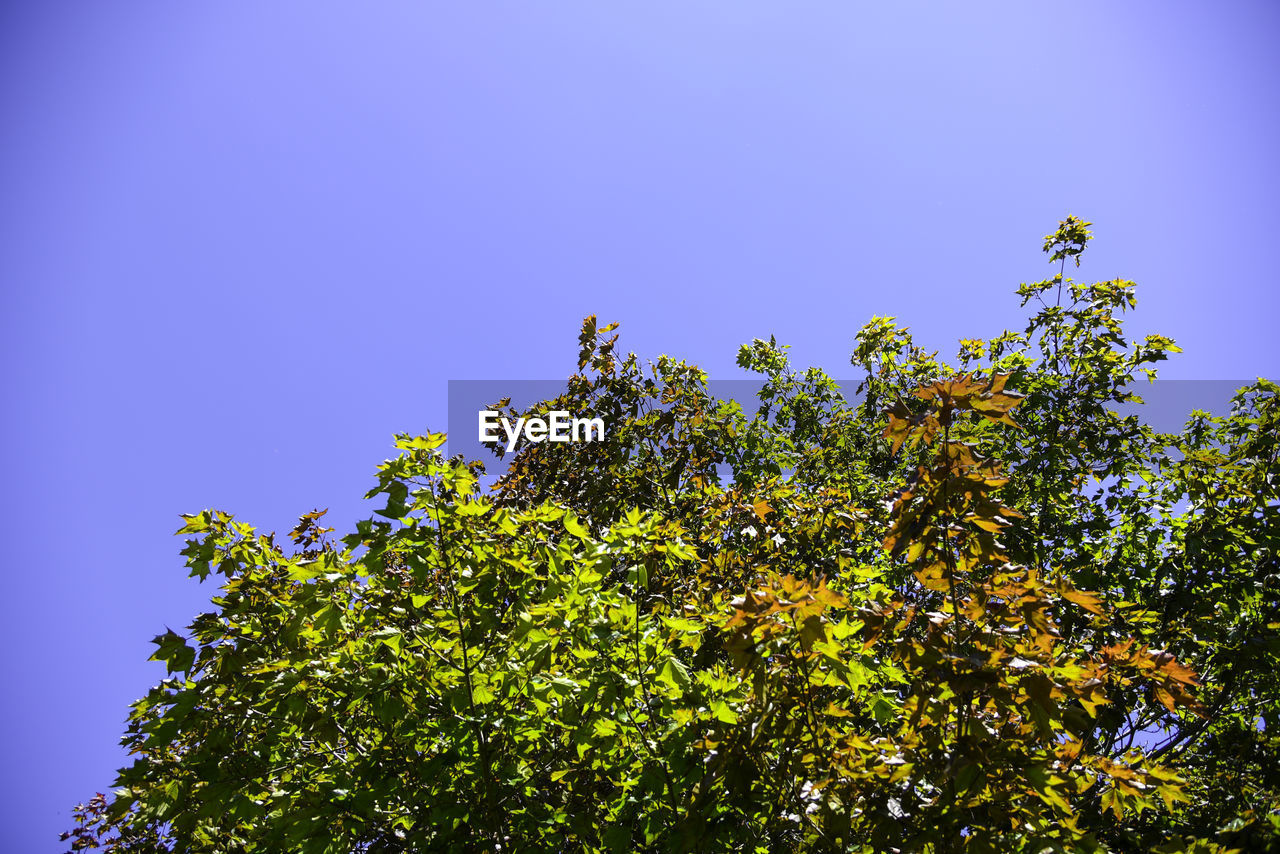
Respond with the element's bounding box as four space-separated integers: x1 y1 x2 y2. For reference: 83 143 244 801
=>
0 0 1280 851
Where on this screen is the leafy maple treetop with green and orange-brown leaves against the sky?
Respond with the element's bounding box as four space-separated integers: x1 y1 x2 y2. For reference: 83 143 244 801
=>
65 218 1280 854
